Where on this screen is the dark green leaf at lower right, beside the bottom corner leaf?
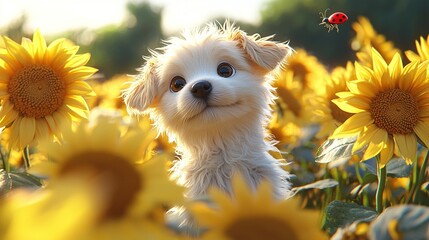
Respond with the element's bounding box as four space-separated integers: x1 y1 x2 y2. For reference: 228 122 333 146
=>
323 200 377 234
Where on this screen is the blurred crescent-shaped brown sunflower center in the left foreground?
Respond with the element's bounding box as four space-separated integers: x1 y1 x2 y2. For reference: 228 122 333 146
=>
60 152 143 219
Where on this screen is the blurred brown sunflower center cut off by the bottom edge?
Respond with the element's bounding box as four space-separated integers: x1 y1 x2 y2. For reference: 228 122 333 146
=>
225 216 298 240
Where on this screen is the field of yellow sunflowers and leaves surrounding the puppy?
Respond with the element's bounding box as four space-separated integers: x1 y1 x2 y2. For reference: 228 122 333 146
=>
0 2 429 240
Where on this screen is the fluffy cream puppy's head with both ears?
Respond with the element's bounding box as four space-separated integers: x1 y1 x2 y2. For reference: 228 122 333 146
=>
124 24 291 138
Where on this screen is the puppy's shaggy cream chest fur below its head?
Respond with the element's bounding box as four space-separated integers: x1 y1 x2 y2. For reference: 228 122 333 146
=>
172 123 290 199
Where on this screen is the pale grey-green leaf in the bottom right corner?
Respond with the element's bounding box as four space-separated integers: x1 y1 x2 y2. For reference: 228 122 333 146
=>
369 205 429 240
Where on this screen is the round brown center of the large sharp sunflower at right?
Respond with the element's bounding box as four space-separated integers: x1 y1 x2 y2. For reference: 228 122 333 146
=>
369 89 419 135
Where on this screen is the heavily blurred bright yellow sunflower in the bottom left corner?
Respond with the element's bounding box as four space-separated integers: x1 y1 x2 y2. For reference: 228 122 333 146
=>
0 179 101 240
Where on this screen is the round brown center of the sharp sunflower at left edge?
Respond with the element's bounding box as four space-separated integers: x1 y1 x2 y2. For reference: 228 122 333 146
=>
8 65 66 118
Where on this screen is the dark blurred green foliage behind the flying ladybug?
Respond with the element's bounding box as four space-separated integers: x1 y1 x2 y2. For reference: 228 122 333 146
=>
258 0 429 66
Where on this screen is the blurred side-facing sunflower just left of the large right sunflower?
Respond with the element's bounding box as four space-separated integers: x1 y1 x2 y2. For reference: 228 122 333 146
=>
313 62 356 138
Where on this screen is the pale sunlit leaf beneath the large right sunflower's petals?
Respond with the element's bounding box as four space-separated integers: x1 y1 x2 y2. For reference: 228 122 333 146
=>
315 137 356 163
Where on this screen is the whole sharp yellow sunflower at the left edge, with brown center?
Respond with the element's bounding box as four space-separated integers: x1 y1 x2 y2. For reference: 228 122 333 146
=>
0 30 97 148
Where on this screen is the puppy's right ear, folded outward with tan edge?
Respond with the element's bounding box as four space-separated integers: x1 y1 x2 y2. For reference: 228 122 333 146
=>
229 29 293 71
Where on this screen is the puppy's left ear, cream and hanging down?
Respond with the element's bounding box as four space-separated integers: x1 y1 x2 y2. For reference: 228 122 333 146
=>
123 57 158 114
